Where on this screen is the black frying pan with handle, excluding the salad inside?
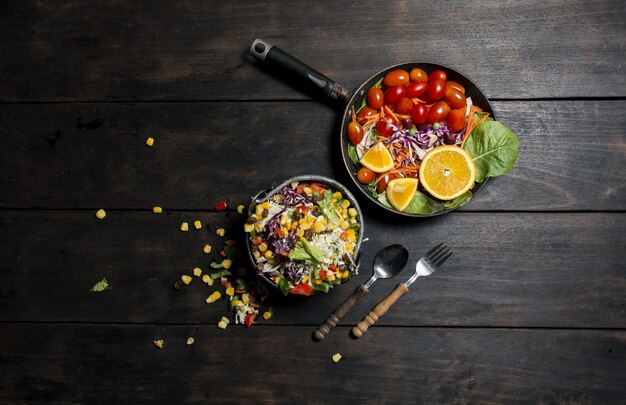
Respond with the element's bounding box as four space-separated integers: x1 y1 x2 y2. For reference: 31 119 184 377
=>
249 39 495 217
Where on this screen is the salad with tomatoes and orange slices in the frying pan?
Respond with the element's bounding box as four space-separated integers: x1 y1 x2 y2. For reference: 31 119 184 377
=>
344 66 518 215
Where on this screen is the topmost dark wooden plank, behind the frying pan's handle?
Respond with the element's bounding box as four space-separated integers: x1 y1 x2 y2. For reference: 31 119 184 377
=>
0 0 626 102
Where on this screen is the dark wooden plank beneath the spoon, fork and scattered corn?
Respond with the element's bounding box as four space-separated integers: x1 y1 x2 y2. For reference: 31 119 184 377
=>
0 210 626 326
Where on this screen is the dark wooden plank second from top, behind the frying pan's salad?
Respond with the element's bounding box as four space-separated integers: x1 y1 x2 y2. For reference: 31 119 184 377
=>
0 100 626 210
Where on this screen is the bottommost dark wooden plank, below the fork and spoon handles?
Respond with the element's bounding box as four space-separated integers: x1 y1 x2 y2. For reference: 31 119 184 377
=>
0 324 626 404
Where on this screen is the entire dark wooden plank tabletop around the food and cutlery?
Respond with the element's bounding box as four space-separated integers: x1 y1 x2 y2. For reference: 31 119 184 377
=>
0 0 626 404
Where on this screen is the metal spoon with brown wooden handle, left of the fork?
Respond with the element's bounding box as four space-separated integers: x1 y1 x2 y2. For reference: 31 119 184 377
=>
313 245 409 340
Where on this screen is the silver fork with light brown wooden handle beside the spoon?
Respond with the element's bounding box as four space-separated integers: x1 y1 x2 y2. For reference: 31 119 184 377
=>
352 243 452 338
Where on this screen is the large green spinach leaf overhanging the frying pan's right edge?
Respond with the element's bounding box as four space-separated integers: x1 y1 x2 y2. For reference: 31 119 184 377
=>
465 121 519 183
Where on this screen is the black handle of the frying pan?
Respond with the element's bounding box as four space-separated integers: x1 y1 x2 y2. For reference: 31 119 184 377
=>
249 38 351 105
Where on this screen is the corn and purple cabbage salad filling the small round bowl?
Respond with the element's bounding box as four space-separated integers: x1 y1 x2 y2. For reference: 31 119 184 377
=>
244 181 362 295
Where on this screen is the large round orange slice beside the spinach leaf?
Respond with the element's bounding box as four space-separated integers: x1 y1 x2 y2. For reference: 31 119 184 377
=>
420 145 476 200
